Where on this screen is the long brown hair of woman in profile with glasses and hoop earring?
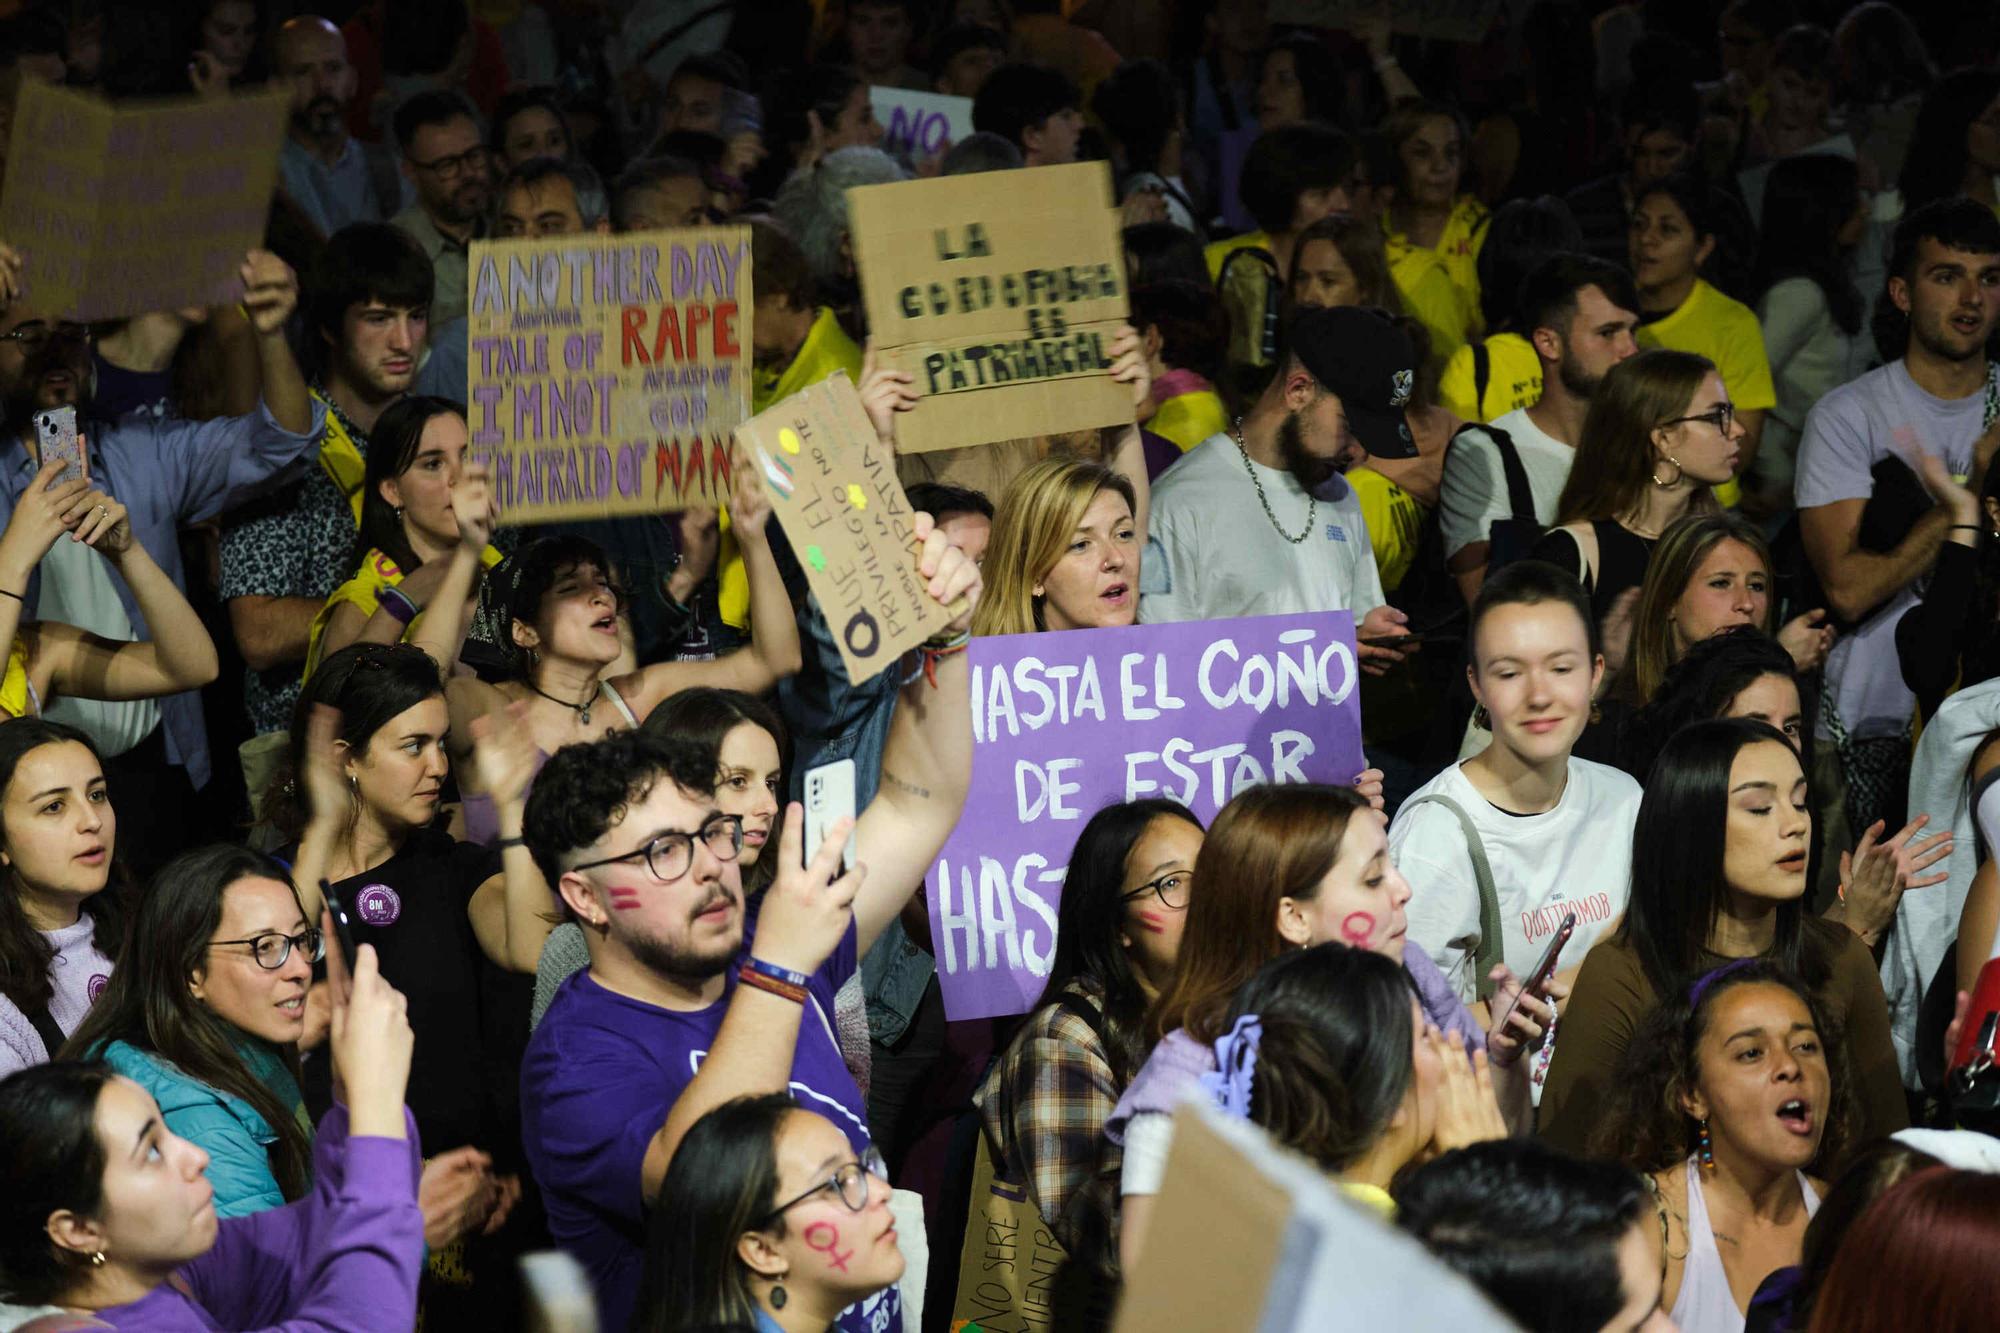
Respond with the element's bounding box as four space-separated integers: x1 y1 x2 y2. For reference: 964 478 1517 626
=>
1554 348 1716 528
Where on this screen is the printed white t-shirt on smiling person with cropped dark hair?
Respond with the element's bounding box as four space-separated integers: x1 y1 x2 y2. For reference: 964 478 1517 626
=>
1388 757 1640 1003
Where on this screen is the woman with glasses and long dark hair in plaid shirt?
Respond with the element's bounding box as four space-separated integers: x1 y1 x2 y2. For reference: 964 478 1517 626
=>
972 799 1202 1327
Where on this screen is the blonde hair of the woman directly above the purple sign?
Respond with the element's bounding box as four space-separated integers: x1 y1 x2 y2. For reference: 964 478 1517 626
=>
972 456 1138 634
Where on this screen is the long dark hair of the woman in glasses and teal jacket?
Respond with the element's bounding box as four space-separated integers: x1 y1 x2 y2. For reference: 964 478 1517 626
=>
62 843 312 1199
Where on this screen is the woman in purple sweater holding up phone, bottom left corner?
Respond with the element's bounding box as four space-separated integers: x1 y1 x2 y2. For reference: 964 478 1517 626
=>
0 932 424 1333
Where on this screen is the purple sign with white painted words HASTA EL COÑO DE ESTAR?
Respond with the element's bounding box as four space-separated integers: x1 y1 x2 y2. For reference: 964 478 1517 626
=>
926 610 1362 1021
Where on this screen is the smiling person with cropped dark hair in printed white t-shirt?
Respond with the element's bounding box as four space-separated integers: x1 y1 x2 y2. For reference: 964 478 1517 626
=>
1390 560 1640 1095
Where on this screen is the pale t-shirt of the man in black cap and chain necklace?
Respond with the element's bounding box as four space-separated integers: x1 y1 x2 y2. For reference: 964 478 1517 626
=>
1138 434 1386 624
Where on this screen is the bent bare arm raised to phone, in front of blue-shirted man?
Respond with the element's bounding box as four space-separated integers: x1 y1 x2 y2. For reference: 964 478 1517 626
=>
36 490 218 701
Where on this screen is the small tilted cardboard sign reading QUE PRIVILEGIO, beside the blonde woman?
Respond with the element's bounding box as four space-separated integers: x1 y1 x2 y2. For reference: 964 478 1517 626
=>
736 370 954 685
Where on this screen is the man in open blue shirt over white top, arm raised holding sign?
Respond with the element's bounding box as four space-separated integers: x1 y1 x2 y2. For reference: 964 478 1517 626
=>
0 244 326 875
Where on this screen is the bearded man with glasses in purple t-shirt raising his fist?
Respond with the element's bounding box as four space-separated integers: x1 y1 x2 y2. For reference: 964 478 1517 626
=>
520 524 978 1333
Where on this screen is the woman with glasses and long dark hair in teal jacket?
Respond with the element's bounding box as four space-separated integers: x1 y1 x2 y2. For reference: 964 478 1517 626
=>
64 845 326 1217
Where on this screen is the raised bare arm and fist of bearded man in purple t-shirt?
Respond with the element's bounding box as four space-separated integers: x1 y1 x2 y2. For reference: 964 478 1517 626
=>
854 514 980 955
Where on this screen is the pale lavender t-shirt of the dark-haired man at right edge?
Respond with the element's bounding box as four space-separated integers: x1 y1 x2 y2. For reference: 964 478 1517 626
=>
1792 360 1986 739
